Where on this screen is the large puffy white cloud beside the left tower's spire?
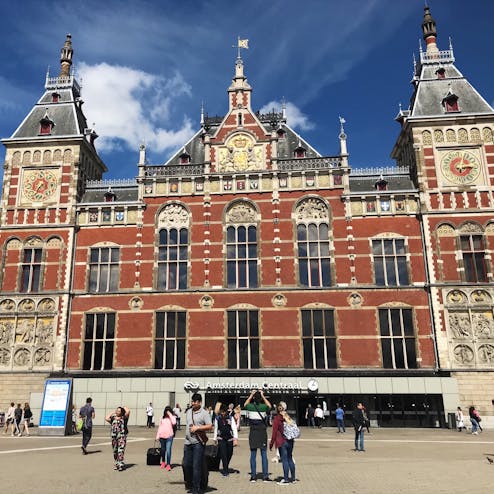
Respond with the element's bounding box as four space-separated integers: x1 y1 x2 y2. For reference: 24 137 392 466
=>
78 63 194 152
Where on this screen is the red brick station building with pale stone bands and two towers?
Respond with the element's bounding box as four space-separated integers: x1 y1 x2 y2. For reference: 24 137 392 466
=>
0 7 494 426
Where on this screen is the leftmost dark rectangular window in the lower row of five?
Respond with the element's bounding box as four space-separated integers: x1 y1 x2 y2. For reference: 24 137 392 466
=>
82 312 115 370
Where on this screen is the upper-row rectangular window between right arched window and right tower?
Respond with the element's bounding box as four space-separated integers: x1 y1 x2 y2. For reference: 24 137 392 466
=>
372 238 409 286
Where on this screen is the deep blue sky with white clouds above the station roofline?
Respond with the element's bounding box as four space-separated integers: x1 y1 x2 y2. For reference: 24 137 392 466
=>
0 0 494 179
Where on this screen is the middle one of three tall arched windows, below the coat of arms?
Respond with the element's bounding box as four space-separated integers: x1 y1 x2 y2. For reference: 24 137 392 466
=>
226 201 258 288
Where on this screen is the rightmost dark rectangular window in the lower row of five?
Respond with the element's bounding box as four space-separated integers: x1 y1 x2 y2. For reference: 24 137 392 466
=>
379 309 417 369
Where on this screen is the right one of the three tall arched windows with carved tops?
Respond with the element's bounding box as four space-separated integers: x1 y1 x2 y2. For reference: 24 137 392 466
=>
295 198 331 287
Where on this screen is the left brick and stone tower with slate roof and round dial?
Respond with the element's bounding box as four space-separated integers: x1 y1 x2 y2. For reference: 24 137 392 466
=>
0 34 106 376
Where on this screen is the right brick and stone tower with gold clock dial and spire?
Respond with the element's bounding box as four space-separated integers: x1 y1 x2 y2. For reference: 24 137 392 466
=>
392 7 494 404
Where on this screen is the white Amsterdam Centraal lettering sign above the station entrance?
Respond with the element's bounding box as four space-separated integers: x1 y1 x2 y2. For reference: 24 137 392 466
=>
184 379 318 393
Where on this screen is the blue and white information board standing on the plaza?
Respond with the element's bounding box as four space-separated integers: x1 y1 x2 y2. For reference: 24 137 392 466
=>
39 379 72 428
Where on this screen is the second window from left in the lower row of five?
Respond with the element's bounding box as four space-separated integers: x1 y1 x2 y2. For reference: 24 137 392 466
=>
154 311 186 369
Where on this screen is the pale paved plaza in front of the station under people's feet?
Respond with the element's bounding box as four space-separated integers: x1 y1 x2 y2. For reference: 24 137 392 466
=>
0 427 494 494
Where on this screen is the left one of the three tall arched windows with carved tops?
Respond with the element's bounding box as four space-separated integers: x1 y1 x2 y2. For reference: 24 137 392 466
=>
157 204 190 290
